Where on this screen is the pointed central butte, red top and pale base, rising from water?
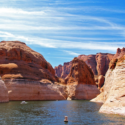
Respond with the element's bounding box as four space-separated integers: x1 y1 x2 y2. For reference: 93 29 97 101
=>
65 58 99 100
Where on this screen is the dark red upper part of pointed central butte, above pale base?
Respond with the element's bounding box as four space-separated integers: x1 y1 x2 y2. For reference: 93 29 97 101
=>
66 58 95 85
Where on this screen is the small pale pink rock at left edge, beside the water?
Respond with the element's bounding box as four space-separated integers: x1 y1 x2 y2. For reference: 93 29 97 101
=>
0 78 9 102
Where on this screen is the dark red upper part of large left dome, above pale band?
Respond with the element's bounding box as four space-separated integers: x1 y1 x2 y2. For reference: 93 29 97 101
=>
0 41 56 81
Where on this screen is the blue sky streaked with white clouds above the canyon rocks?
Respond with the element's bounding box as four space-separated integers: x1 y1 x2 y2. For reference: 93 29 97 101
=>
0 0 125 67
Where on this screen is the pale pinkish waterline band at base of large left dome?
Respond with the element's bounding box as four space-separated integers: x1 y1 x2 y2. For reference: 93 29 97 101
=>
5 79 67 100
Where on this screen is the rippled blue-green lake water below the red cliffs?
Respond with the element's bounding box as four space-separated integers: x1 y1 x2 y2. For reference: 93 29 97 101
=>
0 101 125 125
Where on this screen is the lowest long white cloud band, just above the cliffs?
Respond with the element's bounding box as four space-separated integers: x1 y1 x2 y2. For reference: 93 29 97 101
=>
0 32 124 51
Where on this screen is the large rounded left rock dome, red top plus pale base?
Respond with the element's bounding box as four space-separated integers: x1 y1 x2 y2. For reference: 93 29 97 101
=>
0 41 66 100
